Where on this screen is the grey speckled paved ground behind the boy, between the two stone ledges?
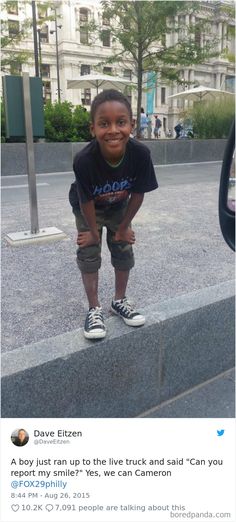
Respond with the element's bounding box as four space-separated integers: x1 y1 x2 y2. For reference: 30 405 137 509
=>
2 165 234 351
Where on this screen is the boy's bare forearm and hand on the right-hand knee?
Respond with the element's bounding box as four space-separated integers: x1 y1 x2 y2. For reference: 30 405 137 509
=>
115 192 144 244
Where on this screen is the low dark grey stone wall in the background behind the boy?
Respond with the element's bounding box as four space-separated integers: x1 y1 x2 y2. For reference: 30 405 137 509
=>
1 139 227 176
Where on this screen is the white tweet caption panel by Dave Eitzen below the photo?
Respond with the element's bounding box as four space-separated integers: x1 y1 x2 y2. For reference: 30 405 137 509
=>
1 419 235 522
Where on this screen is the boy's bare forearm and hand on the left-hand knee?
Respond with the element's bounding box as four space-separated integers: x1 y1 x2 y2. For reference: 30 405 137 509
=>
77 200 100 247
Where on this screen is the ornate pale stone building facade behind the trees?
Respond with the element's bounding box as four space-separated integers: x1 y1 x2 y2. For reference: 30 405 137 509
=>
2 0 234 136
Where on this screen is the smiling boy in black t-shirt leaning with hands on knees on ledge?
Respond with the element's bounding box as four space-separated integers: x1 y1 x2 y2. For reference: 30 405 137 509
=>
69 89 158 339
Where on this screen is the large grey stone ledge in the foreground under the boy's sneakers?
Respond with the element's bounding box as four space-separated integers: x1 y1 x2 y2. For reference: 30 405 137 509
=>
2 281 234 417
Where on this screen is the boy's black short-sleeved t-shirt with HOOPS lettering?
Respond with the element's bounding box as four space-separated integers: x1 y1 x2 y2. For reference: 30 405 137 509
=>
69 138 158 210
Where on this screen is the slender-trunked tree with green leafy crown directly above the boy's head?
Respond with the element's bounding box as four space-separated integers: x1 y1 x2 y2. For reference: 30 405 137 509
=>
90 0 222 135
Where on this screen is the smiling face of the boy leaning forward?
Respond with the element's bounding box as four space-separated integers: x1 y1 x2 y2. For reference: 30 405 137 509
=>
91 101 132 164
